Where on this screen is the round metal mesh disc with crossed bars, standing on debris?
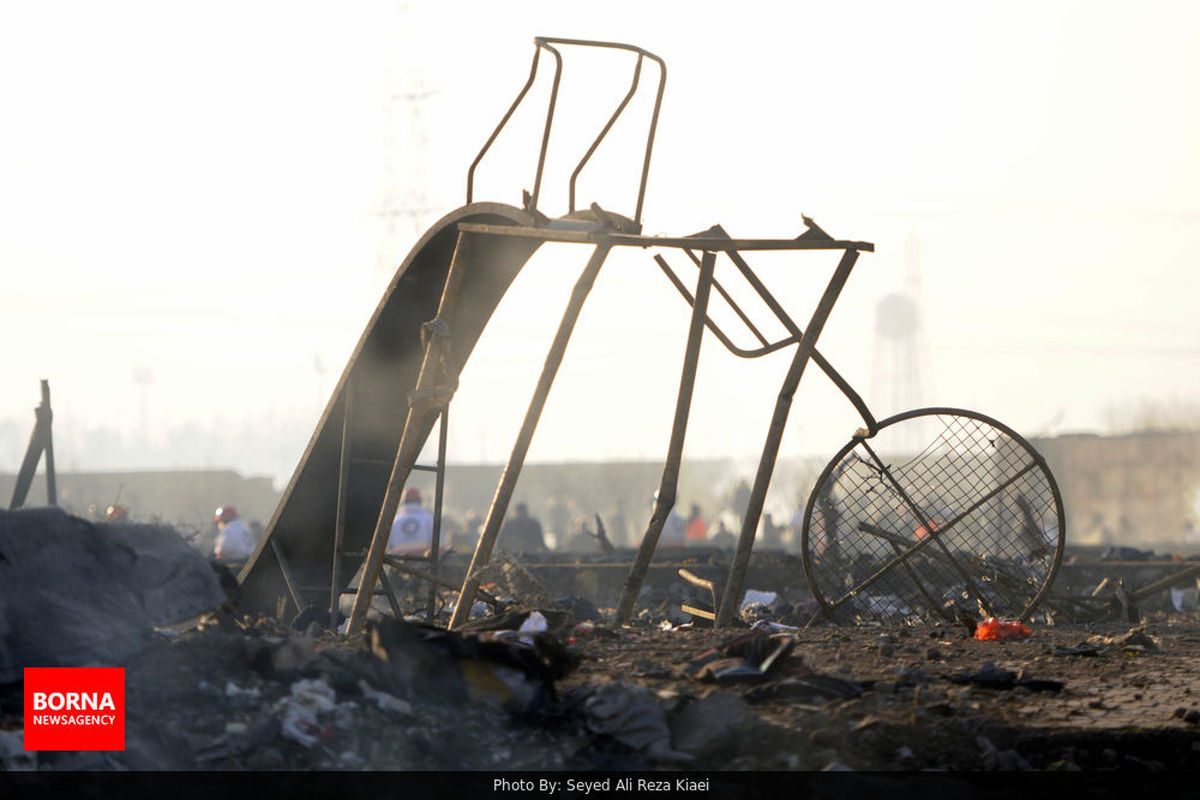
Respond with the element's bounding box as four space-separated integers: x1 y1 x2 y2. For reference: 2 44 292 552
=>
803 409 1064 624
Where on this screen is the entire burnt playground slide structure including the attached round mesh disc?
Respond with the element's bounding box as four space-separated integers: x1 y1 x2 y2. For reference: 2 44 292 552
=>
239 37 1066 632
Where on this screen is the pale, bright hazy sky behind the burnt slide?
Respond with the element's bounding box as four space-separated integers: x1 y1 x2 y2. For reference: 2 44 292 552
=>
0 1 1200 482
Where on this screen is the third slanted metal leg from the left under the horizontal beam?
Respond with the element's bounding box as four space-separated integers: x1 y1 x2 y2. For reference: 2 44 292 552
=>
614 253 716 625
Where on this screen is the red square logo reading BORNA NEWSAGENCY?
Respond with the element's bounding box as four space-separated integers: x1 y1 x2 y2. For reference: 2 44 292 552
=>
25 667 125 750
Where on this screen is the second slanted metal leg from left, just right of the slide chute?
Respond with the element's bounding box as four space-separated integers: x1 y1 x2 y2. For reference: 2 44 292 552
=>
449 243 610 628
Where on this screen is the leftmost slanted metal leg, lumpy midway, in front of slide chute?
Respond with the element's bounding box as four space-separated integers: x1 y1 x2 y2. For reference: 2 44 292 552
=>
347 231 474 634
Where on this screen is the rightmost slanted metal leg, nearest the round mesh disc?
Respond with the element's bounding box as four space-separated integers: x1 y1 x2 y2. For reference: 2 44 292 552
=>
716 249 858 627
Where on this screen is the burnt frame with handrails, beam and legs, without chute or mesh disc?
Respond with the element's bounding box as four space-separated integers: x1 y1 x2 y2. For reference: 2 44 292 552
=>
280 37 876 632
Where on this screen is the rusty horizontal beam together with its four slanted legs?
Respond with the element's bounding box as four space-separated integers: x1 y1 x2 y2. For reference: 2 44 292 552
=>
331 212 874 632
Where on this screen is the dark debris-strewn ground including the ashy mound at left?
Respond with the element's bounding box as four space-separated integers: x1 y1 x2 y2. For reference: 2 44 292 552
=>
0 511 1200 772
